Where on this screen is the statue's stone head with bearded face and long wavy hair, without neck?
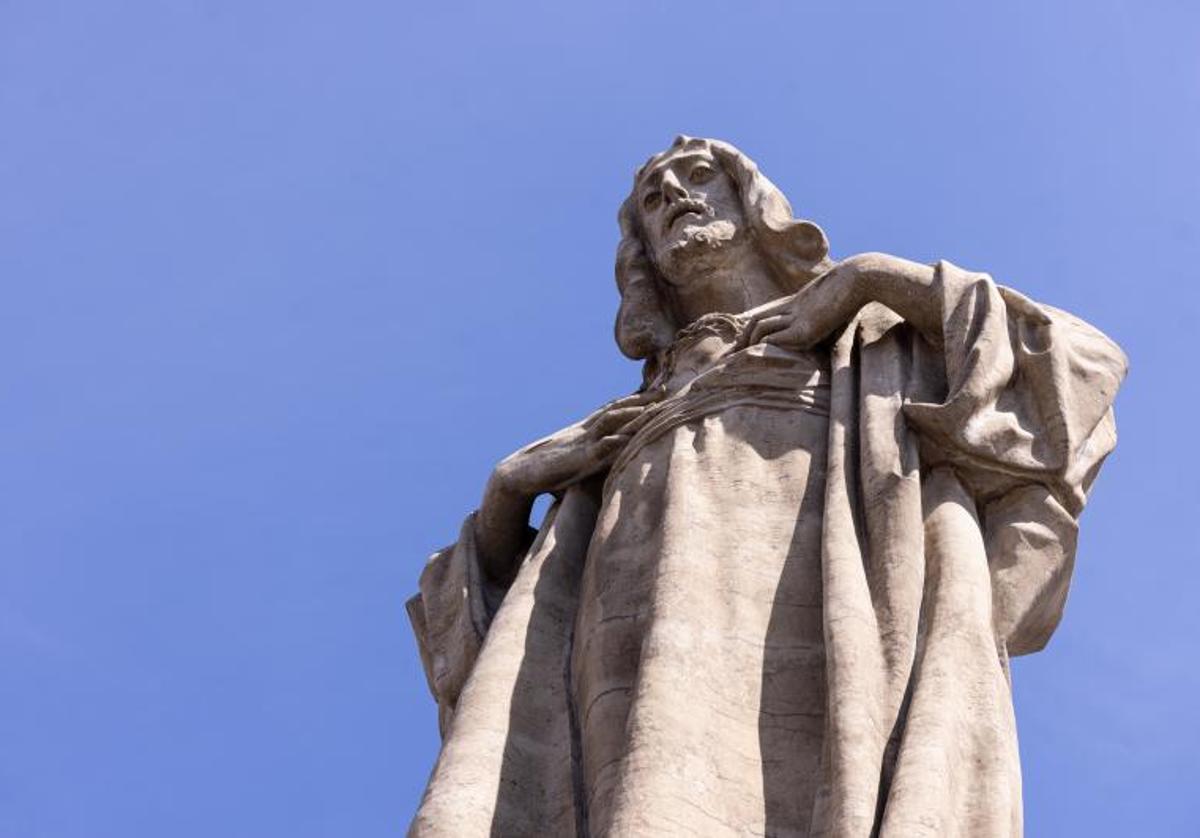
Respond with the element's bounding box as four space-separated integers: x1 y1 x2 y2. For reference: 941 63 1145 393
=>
616 136 830 359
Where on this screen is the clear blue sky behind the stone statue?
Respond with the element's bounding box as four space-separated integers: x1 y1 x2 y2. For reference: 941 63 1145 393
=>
0 0 1200 838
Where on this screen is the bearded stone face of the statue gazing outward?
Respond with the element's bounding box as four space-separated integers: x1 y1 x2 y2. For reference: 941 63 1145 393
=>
636 148 745 285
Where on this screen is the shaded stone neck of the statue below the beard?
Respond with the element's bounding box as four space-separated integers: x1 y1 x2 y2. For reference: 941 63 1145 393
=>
671 247 787 325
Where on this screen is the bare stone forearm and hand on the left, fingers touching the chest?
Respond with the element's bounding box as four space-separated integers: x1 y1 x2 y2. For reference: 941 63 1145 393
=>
475 391 662 583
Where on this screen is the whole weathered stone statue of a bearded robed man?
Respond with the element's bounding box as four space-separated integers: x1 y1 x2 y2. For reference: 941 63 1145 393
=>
408 137 1126 838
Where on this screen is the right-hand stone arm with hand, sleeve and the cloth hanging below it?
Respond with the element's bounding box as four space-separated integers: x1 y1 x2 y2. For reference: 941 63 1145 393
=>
748 253 1127 654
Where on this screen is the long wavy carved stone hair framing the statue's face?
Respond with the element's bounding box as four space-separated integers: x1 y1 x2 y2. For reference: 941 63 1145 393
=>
616 134 832 359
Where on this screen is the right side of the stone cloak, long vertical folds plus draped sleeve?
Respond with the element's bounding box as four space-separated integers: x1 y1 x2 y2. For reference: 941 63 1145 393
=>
814 262 1126 838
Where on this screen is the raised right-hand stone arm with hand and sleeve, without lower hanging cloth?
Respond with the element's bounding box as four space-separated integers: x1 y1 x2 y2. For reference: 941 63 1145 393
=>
745 253 1128 515
